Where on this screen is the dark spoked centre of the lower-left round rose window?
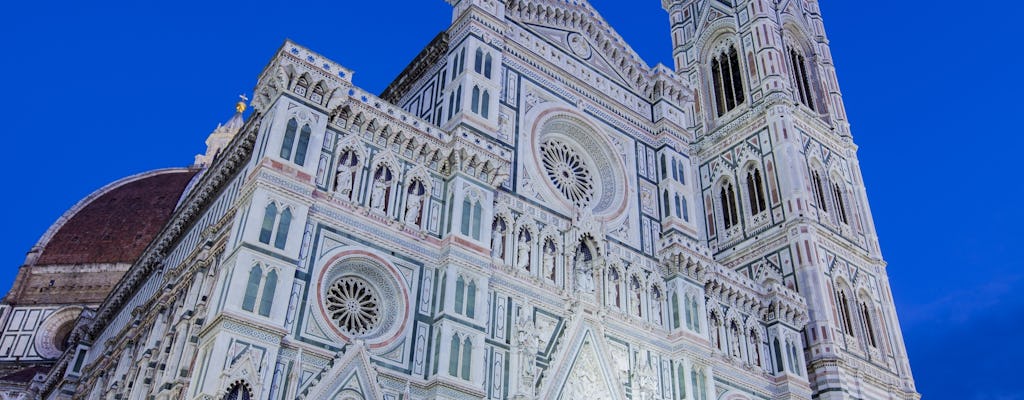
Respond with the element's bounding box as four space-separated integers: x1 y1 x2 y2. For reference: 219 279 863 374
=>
326 276 381 336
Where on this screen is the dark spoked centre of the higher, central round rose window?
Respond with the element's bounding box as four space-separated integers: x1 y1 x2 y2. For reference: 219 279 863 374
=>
541 140 594 207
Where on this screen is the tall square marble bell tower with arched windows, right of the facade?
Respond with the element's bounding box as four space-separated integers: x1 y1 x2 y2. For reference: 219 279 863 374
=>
662 0 920 399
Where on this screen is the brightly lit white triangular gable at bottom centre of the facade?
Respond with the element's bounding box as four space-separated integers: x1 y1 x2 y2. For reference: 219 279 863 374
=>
543 327 626 400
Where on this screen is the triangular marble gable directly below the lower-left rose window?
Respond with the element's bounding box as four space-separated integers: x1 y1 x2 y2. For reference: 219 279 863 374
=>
298 344 384 400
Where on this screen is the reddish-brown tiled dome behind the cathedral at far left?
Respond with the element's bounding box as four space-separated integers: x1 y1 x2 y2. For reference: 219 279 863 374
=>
33 169 198 265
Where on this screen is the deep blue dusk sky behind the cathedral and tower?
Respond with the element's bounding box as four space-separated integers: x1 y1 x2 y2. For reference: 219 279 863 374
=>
0 0 1024 400
